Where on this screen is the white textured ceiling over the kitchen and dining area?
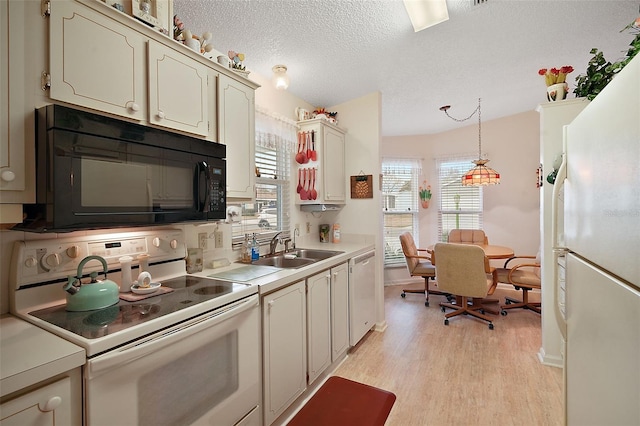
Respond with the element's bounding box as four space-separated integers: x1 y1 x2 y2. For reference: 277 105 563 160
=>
174 0 640 136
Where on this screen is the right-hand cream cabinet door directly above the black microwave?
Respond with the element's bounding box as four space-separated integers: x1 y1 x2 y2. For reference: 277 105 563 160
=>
148 40 209 136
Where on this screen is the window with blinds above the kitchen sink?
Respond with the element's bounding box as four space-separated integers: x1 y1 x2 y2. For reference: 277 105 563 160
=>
232 146 290 245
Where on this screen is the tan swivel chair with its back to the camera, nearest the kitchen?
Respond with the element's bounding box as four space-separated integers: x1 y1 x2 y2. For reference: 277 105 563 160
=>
431 243 498 330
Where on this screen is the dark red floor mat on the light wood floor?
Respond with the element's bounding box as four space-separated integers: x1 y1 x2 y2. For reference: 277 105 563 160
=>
288 376 396 426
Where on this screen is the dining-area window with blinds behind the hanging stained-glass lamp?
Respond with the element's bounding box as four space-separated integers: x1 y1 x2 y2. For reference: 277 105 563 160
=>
437 156 482 241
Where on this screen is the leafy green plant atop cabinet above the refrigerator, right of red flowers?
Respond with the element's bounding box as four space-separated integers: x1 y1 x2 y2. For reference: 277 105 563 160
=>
573 18 640 101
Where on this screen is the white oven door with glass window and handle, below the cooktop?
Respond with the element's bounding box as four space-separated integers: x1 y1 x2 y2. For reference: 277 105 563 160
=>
84 295 261 426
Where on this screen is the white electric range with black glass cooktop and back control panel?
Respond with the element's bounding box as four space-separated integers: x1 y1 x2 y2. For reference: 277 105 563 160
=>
10 229 260 424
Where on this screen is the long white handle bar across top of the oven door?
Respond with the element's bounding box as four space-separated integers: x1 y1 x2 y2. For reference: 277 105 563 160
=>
87 295 259 378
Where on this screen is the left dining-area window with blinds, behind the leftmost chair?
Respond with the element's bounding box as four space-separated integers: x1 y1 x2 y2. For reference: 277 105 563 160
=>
382 159 421 266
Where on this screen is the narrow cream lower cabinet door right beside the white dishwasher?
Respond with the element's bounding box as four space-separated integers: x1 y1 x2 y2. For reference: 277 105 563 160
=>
331 263 349 362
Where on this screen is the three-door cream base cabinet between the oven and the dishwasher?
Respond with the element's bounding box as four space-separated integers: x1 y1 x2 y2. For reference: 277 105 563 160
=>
262 263 349 426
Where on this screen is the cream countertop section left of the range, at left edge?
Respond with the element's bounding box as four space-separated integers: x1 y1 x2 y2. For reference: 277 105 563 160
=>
0 314 86 397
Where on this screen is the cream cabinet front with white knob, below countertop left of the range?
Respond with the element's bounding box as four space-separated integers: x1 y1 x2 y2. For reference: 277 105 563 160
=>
0 377 72 426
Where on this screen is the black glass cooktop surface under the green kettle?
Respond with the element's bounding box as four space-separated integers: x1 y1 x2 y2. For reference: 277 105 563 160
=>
29 275 247 339
